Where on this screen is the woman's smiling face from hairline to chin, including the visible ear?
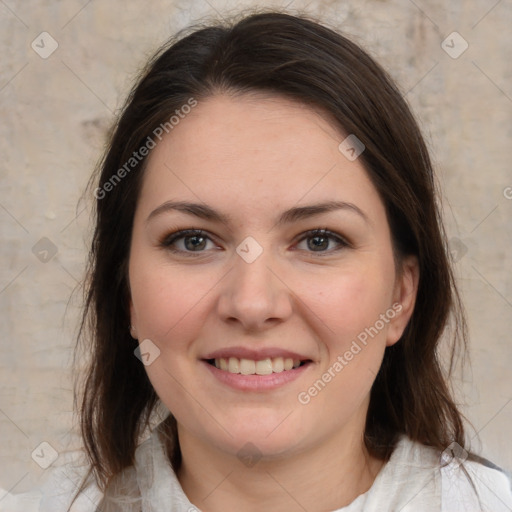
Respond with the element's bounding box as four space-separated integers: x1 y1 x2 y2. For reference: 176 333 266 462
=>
129 95 417 456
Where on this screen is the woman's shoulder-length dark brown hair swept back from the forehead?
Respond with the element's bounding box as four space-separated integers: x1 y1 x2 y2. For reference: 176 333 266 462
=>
77 12 465 500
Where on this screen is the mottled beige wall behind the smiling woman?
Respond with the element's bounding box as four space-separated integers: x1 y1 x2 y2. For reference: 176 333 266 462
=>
0 0 512 492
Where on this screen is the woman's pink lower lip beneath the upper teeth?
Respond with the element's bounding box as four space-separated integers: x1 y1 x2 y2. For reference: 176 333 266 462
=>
202 361 312 391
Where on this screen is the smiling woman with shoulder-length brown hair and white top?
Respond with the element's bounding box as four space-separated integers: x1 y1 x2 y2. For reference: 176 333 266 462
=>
0 8 512 512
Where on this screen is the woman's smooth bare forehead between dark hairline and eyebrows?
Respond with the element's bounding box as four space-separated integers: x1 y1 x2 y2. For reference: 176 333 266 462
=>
136 95 382 226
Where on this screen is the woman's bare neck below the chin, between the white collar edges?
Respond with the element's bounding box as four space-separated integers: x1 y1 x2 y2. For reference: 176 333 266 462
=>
178 414 384 512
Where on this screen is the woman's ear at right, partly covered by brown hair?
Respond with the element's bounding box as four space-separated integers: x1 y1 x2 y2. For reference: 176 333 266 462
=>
386 256 420 347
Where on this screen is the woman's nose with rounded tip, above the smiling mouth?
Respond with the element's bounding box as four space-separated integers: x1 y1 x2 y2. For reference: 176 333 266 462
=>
218 247 293 332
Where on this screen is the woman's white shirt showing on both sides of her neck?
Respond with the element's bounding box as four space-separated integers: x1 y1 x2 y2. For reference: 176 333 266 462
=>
0 429 512 512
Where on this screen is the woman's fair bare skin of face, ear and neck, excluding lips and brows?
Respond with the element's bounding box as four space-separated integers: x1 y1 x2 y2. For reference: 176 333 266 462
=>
129 94 418 512
